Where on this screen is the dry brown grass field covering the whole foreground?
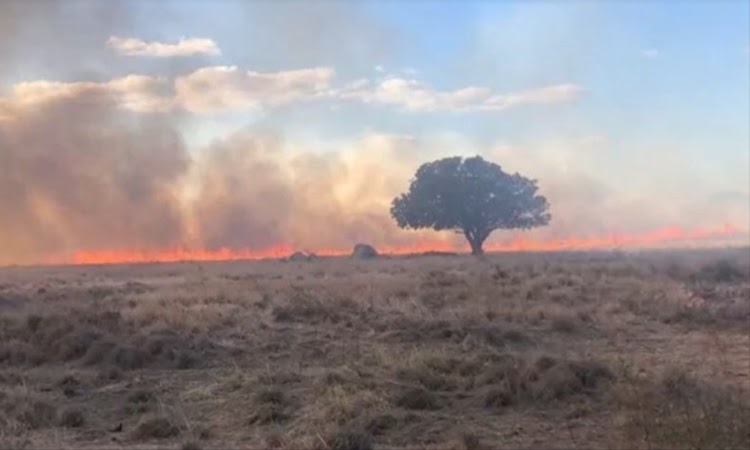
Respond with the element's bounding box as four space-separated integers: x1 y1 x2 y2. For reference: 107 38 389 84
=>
0 249 750 450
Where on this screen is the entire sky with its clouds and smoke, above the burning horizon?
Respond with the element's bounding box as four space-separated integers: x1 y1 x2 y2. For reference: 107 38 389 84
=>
0 0 750 263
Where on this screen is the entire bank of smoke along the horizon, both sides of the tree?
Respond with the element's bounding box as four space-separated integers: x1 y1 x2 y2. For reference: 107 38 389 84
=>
0 78 748 263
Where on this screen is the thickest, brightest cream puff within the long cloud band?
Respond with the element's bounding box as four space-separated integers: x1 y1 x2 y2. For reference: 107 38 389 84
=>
175 66 334 113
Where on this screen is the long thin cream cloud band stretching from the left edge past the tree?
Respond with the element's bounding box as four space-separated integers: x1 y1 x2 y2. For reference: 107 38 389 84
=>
0 66 583 114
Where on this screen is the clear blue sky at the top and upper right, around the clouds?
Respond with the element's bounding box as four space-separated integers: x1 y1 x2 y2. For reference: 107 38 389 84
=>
154 1 750 151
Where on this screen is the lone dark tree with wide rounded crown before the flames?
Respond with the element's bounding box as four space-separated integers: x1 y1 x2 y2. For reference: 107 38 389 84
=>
391 156 550 255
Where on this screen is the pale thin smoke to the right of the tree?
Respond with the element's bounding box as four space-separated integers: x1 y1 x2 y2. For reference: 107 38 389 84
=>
484 137 750 239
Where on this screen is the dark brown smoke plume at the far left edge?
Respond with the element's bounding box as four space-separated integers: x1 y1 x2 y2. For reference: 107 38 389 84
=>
0 90 189 261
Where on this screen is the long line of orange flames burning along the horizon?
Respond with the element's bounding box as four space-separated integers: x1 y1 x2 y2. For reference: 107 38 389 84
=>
47 224 749 264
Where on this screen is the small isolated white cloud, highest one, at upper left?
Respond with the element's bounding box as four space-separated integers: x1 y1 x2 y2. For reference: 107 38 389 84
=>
107 36 221 58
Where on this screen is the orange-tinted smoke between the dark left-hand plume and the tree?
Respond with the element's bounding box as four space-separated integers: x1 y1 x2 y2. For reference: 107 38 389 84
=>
191 130 444 250
